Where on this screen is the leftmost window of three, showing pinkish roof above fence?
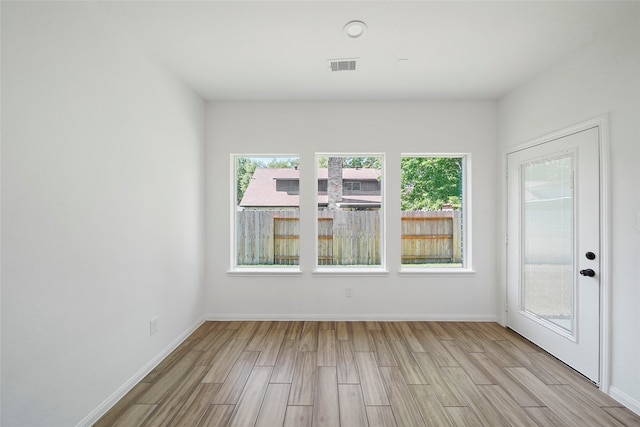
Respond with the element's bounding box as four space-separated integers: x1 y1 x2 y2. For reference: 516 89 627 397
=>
231 155 300 270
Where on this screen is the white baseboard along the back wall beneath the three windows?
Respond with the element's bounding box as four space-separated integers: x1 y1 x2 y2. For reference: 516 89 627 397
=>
206 313 498 322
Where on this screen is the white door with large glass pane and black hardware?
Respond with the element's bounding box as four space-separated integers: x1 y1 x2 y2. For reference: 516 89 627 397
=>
507 127 600 383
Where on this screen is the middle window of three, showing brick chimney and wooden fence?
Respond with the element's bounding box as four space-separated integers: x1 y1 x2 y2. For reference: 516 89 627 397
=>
316 153 384 271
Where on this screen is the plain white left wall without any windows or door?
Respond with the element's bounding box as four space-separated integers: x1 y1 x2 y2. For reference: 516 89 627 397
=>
1 2 205 427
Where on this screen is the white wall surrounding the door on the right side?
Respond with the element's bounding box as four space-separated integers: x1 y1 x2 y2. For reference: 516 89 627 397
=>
498 22 640 413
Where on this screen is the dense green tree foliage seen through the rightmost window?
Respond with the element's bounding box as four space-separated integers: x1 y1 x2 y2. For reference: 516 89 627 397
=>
401 157 462 211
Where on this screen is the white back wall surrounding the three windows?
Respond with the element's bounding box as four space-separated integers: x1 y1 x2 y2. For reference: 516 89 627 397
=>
206 102 500 320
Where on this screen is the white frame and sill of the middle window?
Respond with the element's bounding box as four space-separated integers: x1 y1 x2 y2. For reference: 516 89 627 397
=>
313 151 389 276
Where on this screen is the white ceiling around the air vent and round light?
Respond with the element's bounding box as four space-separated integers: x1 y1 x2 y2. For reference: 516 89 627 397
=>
99 0 640 100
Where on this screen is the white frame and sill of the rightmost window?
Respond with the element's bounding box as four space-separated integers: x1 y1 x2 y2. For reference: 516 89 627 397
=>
398 152 475 276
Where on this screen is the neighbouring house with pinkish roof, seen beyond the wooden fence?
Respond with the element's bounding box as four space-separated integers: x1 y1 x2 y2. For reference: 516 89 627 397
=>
239 168 381 209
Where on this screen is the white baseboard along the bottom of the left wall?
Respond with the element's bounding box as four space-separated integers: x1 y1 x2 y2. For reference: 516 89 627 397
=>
76 317 207 427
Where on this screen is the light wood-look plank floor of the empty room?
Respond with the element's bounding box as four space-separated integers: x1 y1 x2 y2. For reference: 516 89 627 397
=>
95 321 640 427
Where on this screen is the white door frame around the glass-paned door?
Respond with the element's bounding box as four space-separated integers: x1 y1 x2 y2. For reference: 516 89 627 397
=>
498 115 611 394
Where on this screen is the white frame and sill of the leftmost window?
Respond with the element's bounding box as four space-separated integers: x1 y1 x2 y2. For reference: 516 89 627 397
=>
227 153 302 275
